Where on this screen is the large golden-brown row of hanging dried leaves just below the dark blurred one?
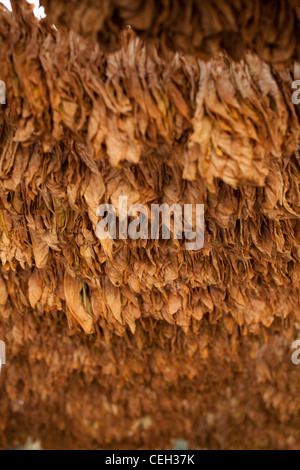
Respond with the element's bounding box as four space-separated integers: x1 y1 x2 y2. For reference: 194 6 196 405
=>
0 4 299 189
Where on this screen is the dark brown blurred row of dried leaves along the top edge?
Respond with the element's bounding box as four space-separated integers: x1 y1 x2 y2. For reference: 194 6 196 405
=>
41 0 300 64
